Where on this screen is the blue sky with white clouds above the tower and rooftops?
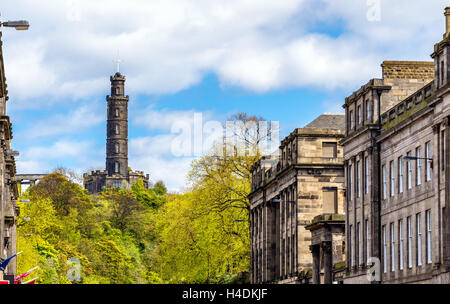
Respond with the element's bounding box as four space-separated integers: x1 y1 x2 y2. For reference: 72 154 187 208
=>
0 0 450 192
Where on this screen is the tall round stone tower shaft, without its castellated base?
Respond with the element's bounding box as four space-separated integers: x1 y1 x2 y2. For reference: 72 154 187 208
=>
106 72 129 177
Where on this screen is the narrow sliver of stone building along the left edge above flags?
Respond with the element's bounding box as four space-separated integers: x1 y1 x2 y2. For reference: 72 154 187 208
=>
0 31 19 280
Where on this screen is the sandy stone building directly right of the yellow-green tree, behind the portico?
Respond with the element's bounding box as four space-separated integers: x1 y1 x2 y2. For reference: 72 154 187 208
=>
249 114 345 283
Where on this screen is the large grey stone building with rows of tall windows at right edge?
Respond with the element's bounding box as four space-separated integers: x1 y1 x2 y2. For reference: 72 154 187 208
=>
341 8 450 283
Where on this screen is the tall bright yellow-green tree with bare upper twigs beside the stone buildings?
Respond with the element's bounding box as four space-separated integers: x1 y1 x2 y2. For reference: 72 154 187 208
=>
156 114 268 283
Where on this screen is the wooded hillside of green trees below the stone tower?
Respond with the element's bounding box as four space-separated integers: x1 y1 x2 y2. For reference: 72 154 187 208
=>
17 173 166 284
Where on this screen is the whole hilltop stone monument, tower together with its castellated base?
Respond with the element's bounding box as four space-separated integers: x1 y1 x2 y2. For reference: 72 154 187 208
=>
83 72 149 193
